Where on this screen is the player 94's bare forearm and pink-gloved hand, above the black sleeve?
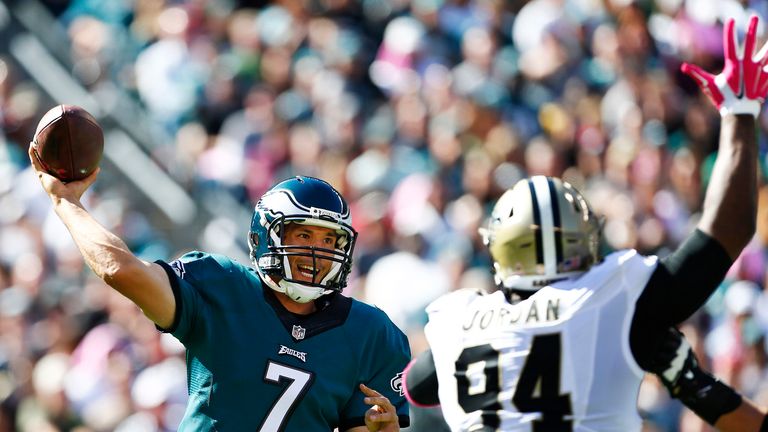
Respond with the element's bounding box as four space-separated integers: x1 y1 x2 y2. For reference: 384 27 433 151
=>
681 16 768 259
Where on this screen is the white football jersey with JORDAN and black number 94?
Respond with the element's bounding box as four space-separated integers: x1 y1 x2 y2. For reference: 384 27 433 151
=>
425 250 657 432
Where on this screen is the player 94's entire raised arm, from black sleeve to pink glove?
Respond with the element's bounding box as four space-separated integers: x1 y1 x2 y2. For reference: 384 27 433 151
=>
630 17 768 365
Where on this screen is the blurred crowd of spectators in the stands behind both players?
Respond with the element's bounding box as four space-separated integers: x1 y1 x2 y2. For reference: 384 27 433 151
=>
0 0 768 432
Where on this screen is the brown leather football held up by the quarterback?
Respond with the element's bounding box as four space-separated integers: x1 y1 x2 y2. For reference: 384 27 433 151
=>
32 105 104 182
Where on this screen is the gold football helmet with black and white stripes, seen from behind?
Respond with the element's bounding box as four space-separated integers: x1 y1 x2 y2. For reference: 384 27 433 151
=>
480 176 600 292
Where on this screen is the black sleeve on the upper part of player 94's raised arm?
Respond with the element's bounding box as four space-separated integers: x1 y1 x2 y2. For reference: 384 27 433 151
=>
630 229 733 368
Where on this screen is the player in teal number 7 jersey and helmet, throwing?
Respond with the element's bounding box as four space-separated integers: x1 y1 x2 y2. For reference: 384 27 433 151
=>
30 167 410 432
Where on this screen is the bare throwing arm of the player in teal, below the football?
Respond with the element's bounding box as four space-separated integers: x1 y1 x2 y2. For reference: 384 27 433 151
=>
28 145 176 328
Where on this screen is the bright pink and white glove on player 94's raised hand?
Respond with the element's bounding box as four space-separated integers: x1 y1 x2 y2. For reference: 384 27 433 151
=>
680 15 768 117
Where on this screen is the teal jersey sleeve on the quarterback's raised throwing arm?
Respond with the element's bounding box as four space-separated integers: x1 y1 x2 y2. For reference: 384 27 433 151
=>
157 251 238 345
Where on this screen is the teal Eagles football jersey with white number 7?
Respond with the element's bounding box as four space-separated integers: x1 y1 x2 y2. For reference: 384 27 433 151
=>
159 252 410 432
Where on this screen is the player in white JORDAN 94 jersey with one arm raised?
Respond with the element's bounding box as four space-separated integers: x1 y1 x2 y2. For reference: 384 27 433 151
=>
405 17 768 432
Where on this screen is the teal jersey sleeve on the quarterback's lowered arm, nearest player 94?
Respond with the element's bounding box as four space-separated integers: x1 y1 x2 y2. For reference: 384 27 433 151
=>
339 308 411 431
